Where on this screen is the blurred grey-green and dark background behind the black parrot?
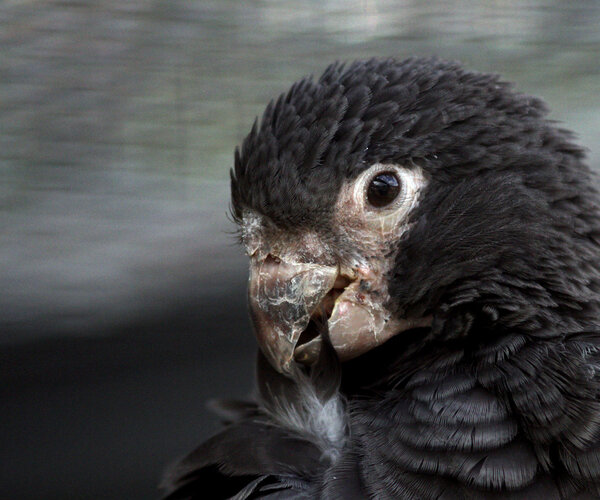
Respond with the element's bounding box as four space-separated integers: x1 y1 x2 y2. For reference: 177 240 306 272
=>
0 0 600 499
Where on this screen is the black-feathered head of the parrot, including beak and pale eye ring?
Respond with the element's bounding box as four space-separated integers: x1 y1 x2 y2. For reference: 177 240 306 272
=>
231 59 600 373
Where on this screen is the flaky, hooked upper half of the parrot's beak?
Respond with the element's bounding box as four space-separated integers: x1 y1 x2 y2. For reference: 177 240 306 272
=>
248 255 338 373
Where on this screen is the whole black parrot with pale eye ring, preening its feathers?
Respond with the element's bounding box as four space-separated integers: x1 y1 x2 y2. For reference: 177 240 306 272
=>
164 58 600 500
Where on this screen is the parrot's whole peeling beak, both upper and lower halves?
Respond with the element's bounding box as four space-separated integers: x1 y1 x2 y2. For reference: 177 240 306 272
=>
248 254 431 373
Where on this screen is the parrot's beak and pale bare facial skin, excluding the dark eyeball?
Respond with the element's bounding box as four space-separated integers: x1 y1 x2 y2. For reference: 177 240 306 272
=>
243 164 431 373
